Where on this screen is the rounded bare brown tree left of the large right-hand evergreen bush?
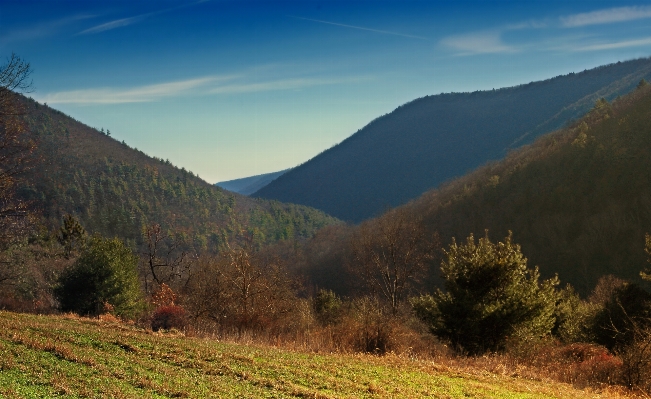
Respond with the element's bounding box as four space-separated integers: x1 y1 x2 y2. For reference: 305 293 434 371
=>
348 210 438 316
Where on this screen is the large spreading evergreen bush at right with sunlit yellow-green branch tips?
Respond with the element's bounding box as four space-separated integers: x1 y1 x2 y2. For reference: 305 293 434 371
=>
412 235 558 355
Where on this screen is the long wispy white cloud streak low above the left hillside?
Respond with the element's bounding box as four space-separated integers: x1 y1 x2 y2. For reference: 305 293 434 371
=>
36 75 369 105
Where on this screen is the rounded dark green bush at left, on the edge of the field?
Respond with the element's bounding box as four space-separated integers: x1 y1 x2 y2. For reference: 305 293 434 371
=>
55 236 143 318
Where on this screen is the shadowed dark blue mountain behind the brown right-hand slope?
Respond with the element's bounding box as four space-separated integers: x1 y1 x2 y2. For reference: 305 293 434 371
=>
254 58 651 222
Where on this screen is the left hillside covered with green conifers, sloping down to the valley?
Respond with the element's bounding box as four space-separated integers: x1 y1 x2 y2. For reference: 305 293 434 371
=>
17 99 339 249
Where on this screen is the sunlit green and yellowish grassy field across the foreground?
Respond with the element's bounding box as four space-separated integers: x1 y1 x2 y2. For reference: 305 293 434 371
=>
0 312 632 398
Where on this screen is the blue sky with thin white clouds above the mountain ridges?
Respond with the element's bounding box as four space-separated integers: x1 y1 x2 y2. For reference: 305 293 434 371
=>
0 0 651 183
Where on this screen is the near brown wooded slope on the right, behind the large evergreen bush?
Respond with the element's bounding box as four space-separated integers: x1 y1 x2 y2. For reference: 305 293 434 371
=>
405 85 651 294
